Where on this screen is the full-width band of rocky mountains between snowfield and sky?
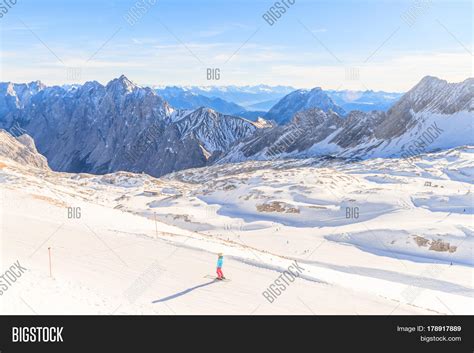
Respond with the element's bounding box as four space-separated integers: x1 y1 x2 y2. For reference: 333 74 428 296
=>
0 76 474 176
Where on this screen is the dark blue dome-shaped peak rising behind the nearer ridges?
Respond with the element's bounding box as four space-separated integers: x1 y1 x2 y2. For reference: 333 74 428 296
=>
265 87 345 124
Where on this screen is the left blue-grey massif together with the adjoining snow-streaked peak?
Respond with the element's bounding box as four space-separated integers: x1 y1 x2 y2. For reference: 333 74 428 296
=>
0 76 256 176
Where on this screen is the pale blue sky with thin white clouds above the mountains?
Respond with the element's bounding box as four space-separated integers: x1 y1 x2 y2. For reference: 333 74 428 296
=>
0 0 473 91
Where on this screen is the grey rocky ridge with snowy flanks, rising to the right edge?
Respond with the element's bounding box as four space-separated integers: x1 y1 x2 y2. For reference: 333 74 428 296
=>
219 77 474 162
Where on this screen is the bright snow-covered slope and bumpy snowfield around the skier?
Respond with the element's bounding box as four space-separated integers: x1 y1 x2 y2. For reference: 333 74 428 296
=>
0 147 474 315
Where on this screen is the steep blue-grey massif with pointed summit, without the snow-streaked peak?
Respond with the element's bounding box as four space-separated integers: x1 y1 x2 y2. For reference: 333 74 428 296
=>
5 77 169 173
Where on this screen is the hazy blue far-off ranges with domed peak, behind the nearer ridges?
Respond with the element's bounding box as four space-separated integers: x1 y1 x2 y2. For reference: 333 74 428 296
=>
156 85 402 123
